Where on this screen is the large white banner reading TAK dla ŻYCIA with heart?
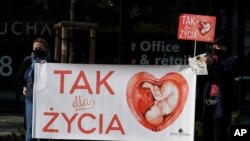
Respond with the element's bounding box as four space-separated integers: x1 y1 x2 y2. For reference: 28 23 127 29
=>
32 63 196 141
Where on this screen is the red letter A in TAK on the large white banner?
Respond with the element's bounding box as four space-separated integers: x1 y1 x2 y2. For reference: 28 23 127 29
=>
70 71 93 94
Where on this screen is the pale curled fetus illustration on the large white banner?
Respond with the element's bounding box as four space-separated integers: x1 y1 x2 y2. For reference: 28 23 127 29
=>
142 82 179 125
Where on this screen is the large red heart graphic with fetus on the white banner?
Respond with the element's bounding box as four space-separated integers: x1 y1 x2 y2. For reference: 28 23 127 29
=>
127 72 188 132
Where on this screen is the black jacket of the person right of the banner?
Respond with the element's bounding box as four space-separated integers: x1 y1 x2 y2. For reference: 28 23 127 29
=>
196 56 238 120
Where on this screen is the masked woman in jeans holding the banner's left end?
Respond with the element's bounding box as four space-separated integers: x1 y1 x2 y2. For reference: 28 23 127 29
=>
18 38 56 141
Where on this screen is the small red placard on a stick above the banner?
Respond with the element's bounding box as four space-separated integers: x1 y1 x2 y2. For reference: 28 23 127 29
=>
178 14 216 42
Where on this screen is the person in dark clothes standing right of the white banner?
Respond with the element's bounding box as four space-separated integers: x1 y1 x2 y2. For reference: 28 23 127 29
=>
196 36 237 141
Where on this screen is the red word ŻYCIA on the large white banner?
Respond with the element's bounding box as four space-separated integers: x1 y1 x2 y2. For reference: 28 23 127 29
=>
43 112 125 135
